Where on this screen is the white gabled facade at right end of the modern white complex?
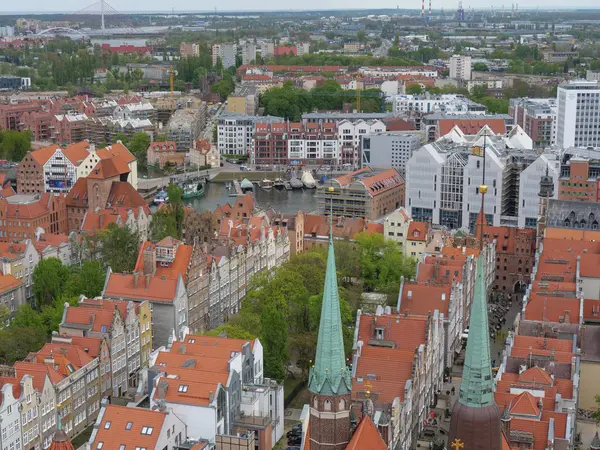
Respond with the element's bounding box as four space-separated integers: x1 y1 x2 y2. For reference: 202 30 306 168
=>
519 153 560 228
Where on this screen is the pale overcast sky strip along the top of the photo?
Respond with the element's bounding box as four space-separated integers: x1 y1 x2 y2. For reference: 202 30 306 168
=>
0 0 600 14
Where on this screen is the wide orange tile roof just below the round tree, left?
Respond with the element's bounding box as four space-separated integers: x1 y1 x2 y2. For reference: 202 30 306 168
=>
104 273 177 303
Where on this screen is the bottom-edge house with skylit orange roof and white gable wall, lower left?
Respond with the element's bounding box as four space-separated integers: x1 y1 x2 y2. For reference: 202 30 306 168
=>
86 402 191 450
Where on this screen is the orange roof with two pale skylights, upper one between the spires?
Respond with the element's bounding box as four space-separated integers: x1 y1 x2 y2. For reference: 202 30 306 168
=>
400 281 452 318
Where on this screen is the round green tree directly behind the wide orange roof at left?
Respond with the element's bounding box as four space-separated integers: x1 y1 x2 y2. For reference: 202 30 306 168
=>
99 223 139 273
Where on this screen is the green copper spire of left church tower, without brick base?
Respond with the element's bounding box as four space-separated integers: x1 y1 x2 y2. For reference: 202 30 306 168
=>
308 225 352 395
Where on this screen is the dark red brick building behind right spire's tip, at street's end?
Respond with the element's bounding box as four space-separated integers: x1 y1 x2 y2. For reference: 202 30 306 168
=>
476 225 536 294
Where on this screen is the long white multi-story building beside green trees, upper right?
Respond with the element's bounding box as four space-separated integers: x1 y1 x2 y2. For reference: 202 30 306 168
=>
393 93 486 115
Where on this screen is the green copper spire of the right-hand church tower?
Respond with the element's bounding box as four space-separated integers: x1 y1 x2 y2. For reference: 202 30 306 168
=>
459 251 494 408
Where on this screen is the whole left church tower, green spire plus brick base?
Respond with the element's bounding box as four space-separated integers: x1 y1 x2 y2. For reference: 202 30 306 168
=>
308 207 352 450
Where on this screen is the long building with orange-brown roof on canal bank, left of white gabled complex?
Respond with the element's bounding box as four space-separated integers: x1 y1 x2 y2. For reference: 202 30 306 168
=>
317 167 404 220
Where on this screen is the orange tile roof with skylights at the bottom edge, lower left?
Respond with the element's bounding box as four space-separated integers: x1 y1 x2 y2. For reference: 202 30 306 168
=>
92 405 167 450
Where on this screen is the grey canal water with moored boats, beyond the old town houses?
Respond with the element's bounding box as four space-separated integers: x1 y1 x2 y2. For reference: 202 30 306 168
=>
184 183 317 214
